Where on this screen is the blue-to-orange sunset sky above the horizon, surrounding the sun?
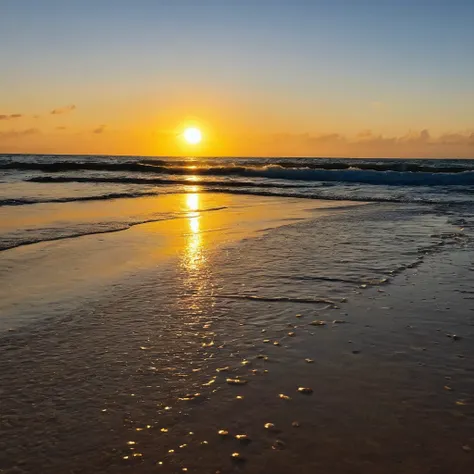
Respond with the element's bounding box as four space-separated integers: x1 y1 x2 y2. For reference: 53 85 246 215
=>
0 0 474 158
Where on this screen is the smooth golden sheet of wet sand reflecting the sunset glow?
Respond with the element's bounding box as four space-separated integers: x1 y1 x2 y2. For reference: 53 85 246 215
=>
0 192 364 330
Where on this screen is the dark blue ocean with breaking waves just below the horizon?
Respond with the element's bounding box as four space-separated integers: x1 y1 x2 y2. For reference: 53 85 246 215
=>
0 155 474 249
